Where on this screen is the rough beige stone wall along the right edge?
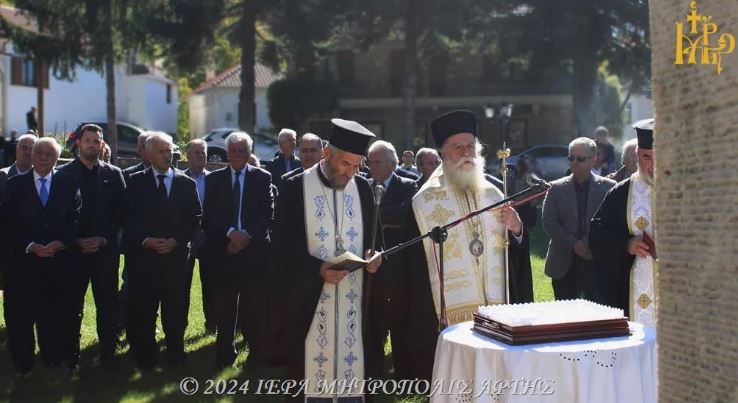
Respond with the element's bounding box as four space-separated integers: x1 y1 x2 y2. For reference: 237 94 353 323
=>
650 0 738 402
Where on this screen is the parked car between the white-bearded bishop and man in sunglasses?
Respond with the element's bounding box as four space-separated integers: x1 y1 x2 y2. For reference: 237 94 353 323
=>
487 144 569 180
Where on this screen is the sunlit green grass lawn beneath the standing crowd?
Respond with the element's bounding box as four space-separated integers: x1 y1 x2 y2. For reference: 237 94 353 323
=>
0 207 553 402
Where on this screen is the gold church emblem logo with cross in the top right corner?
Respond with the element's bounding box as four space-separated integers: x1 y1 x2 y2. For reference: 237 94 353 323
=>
674 1 735 75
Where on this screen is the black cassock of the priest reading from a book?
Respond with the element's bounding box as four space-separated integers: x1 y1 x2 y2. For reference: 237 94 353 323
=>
275 171 381 386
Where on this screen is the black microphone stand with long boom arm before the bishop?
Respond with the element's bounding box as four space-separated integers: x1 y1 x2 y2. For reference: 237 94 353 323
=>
382 182 551 330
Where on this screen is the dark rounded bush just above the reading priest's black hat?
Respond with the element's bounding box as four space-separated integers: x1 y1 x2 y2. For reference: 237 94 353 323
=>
267 79 337 127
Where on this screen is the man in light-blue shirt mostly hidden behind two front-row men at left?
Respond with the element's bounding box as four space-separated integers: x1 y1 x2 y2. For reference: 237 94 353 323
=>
184 139 214 333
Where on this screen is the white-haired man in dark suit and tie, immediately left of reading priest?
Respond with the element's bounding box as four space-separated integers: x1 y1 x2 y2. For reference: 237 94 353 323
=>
203 132 274 367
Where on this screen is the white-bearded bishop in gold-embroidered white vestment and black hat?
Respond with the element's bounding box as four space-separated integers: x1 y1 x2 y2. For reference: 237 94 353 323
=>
407 110 527 379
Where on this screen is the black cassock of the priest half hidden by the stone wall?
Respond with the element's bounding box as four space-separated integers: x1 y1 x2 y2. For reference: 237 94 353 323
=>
589 178 635 315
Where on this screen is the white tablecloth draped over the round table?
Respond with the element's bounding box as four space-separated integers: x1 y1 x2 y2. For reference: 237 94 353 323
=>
431 322 657 403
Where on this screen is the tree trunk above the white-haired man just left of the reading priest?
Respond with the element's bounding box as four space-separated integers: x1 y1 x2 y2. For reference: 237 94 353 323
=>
238 0 258 134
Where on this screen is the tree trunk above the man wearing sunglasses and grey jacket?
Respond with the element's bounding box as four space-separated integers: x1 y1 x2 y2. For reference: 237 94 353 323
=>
573 52 597 137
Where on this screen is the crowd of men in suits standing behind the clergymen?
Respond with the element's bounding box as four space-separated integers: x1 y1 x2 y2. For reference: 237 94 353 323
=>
0 119 632 379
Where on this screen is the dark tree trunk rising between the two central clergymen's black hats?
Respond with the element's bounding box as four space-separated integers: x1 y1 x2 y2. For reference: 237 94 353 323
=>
400 0 418 152
